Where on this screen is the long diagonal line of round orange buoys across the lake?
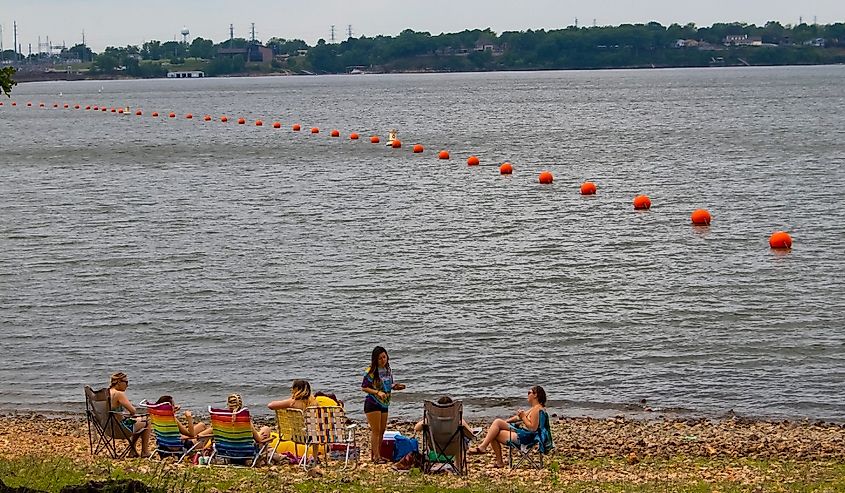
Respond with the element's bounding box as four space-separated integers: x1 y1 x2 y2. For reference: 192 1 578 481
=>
0 101 792 250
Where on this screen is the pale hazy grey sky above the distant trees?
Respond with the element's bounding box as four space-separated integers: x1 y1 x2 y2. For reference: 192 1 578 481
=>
0 0 845 52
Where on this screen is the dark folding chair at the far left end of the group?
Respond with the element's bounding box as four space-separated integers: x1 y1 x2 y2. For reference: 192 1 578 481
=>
85 385 143 459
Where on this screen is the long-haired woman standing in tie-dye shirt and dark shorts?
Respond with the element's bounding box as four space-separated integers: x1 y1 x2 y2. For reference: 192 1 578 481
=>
361 346 405 464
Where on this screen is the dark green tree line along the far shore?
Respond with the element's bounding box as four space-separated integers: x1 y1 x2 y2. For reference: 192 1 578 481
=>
3 21 845 77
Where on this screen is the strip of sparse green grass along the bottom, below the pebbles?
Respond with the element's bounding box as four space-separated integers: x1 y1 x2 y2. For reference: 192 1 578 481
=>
0 457 845 493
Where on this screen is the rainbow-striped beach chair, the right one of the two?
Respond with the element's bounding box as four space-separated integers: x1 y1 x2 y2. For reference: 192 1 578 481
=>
208 406 266 467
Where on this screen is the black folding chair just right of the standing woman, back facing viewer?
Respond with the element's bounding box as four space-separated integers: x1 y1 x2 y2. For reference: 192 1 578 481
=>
422 401 468 475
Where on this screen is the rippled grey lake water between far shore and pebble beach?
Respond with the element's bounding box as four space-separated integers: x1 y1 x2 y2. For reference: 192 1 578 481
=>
0 66 845 421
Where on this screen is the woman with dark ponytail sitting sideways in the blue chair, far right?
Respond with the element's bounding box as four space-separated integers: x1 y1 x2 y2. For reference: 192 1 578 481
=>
469 385 546 467
